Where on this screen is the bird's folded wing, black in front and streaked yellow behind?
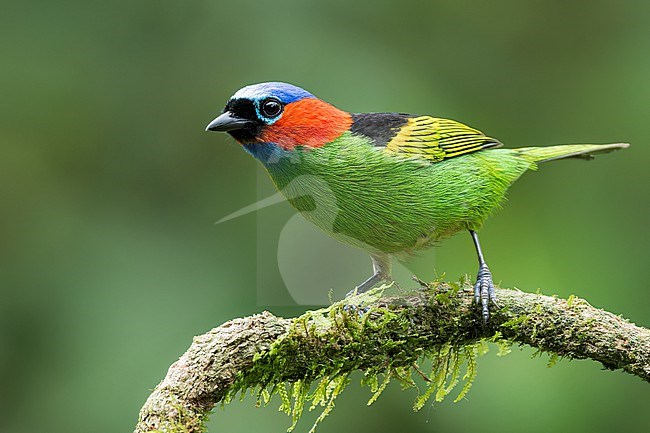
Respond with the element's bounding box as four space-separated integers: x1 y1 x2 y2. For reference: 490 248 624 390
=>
351 113 502 163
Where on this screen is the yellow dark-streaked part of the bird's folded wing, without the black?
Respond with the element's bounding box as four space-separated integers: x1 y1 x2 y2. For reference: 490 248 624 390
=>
386 116 503 162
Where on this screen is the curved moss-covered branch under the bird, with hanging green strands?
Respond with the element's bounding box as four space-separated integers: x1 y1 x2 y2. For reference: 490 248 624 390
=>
135 283 650 433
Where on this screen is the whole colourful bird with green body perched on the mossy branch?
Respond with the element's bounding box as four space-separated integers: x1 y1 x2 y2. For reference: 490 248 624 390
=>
206 82 629 322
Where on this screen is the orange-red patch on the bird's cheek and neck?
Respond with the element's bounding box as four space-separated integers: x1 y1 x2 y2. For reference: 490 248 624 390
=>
258 98 352 150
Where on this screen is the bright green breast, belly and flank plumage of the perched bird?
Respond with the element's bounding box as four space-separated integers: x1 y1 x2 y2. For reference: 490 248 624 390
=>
258 133 531 254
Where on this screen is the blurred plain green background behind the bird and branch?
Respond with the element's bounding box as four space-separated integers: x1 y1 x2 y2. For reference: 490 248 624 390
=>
0 0 650 433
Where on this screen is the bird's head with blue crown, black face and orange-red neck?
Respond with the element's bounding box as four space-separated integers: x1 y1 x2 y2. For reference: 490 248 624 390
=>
206 82 352 156
